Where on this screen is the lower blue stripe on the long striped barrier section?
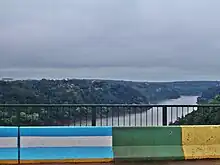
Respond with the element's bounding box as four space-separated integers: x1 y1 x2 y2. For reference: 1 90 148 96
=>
21 147 113 160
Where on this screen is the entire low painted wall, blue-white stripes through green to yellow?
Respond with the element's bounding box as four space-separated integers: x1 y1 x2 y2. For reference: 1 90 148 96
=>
0 126 220 164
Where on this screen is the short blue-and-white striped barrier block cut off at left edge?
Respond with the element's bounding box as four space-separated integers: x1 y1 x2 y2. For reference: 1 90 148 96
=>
0 127 18 164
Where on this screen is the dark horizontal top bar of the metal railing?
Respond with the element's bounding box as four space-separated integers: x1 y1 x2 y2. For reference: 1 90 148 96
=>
0 104 220 108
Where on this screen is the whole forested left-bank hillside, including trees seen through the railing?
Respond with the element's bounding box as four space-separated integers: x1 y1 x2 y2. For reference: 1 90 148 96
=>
0 79 180 125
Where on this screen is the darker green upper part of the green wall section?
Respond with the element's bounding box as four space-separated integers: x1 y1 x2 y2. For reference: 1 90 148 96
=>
112 127 182 146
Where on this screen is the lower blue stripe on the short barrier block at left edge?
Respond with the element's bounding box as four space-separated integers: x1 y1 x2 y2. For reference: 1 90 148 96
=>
0 148 18 160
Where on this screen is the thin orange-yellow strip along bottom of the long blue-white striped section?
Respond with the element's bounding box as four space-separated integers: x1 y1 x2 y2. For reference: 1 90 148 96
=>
21 159 113 164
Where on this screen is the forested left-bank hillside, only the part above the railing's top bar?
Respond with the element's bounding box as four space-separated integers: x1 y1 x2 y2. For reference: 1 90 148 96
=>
0 79 180 104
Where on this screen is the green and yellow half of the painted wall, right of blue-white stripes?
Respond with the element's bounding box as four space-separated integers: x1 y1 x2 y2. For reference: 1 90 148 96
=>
113 125 220 160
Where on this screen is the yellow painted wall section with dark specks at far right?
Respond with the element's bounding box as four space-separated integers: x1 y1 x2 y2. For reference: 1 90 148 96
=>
181 126 220 159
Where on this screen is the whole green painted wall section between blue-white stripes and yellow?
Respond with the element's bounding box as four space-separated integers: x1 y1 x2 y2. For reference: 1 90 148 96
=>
113 127 184 160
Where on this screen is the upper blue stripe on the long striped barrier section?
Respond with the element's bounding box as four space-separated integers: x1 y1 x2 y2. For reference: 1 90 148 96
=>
20 126 112 136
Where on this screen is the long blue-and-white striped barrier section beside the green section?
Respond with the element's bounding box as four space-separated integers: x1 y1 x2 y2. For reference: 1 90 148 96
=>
20 127 113 163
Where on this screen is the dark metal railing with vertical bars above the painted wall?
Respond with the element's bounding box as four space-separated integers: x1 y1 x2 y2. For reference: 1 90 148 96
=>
0 104 220 126
